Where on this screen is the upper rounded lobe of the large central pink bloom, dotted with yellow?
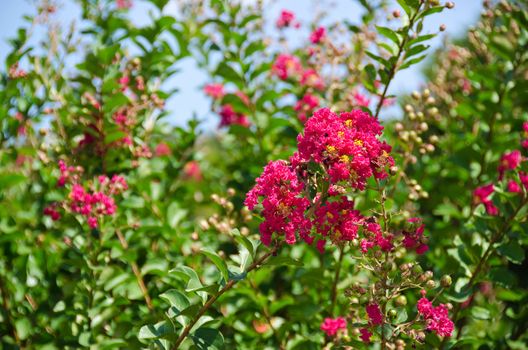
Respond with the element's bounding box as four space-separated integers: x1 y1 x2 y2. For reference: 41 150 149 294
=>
297 108 394 190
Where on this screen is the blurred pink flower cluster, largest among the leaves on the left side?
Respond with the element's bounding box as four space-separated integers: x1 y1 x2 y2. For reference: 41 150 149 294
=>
44 160 128 228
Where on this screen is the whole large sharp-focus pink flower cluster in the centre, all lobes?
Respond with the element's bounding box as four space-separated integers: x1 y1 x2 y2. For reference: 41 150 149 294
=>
245 109 393 253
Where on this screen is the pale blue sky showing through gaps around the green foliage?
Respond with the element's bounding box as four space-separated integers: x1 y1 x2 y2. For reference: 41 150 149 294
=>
0 0 482 128
